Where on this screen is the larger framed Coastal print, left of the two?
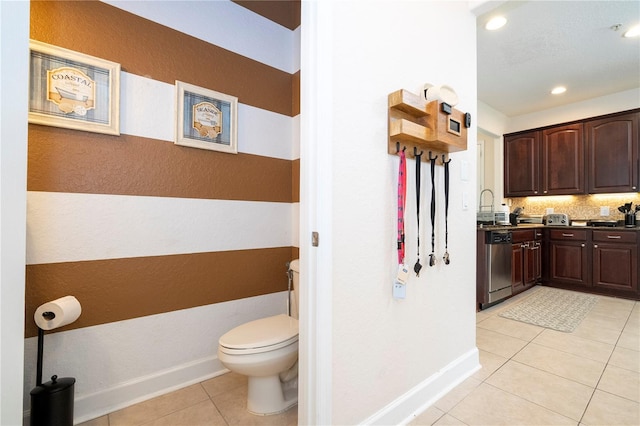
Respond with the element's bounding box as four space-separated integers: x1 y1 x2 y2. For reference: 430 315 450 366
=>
29 40 120 135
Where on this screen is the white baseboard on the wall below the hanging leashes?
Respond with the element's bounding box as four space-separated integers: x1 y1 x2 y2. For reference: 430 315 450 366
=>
361 347 481 425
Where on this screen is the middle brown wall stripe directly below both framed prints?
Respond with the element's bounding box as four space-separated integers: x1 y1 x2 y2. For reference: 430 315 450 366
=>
27 124 293 202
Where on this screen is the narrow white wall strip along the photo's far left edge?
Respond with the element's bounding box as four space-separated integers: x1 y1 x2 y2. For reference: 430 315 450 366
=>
0 1 29 426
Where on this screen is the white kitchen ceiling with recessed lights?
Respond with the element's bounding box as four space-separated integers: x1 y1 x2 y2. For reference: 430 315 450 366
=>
477 0 640 117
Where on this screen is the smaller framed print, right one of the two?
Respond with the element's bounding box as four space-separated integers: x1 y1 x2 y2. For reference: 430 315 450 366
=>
175 81 238 154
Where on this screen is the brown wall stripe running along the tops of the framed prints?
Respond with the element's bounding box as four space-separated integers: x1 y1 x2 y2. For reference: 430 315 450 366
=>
31 1 293 116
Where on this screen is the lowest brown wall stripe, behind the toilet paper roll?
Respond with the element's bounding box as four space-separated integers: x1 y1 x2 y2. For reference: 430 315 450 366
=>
25 247 292 337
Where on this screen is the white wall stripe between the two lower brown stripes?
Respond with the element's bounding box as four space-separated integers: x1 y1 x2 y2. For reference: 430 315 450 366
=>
27 191 292 264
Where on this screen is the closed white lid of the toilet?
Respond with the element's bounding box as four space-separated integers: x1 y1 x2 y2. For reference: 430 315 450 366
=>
219 314 298 349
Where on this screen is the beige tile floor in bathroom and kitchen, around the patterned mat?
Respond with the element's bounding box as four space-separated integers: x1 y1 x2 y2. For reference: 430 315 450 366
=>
82 288 640 426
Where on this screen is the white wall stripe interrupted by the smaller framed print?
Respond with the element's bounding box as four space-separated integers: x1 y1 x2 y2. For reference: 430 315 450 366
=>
120 72 299 160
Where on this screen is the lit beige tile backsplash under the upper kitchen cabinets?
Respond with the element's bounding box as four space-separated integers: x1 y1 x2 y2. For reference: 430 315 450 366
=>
509 193 640 220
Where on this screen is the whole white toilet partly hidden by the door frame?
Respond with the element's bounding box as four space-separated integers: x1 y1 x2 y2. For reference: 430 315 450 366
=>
218 259 300 416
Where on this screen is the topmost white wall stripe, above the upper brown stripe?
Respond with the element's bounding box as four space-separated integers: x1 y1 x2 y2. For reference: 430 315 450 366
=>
102 0 300 74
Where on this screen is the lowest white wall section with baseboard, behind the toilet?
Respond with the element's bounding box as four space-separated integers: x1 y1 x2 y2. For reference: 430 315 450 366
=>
24 292 287 421
